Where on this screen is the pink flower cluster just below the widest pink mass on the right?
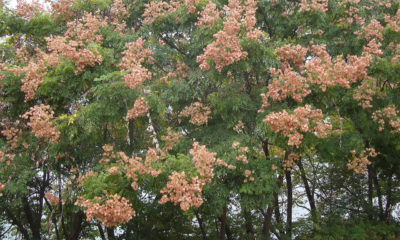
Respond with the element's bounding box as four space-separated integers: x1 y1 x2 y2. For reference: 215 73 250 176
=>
264 105 332 147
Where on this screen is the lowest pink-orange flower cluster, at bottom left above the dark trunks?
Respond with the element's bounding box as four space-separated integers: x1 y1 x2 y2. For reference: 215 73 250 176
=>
75 194 135 227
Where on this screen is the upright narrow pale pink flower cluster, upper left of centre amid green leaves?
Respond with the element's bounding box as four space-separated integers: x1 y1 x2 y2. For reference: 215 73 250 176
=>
118 38 153 89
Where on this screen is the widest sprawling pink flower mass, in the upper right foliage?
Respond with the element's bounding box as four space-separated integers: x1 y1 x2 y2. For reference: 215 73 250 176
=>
260 45 371 109
